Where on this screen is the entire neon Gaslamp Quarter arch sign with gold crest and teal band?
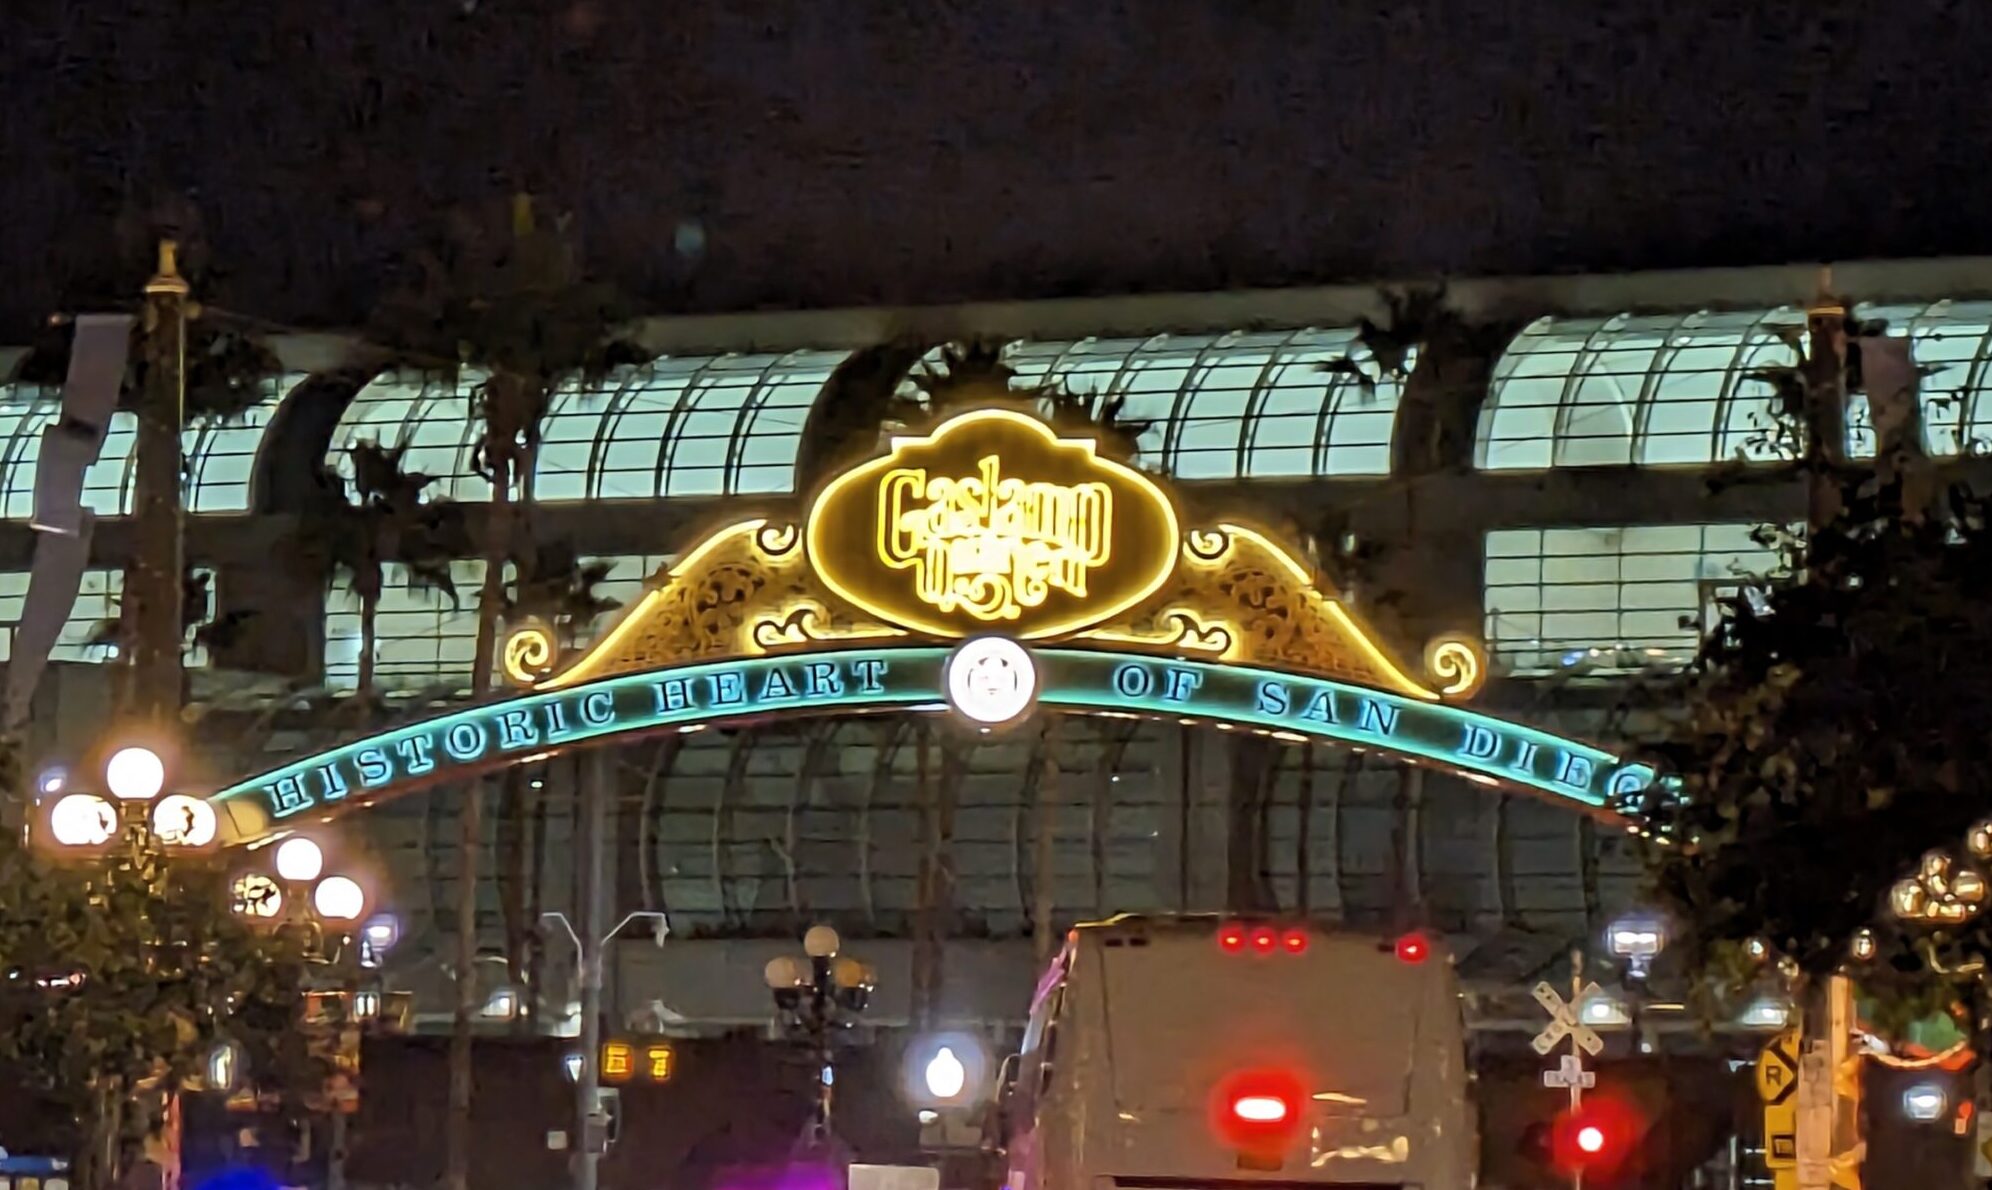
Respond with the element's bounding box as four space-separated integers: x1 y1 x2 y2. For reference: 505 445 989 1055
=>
213 407 1653 839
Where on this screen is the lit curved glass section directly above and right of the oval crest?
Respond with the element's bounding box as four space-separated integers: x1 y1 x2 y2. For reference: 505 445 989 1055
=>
1006 327 1402 478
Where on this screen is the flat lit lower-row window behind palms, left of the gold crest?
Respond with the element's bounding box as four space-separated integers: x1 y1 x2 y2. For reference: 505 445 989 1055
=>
325 554 671 690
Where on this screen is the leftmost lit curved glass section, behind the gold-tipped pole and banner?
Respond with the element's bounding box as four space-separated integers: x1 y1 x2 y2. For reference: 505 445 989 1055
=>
0 375 305 520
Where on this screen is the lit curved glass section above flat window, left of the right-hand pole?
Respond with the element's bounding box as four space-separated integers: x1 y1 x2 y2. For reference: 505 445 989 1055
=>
1474 309 1805 470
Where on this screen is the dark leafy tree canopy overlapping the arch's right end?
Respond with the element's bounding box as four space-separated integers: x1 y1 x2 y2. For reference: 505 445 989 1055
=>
1629 478 1992 985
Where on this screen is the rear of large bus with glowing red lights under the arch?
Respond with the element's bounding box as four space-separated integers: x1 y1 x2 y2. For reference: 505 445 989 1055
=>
1010 919 1476 1190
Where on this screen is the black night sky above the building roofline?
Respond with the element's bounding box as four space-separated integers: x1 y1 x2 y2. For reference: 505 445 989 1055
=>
0 0 1992 341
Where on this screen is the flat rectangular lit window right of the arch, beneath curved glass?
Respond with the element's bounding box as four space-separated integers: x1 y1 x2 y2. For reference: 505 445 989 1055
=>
1484 524 1781 676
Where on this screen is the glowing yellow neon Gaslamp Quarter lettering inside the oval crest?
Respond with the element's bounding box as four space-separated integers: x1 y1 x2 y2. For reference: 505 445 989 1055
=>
878 454 1114 620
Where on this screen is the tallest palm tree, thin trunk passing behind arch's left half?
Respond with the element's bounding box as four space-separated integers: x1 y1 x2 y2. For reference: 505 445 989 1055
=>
369 193 645 1190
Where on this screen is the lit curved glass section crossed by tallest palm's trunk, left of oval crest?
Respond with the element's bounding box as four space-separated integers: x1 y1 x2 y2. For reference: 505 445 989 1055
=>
331 351 849 500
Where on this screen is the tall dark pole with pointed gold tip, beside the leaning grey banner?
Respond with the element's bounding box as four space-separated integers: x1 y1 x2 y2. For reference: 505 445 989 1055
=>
124 239 191 724
